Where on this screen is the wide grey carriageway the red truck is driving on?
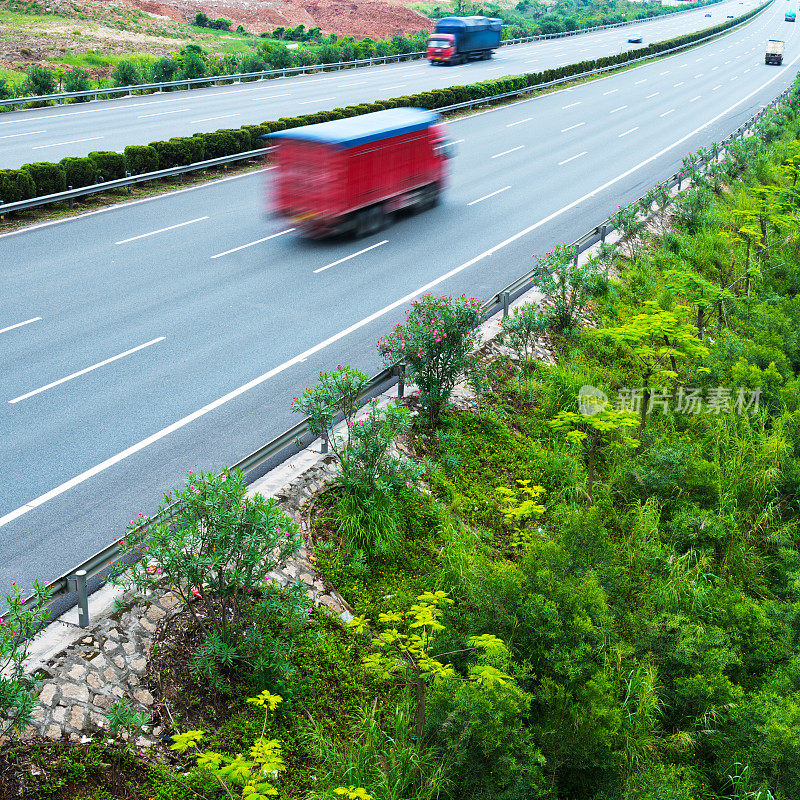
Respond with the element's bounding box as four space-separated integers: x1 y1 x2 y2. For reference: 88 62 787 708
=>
0 3 800 588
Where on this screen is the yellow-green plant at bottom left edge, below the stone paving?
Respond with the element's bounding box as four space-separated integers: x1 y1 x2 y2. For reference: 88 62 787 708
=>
170 690 284 800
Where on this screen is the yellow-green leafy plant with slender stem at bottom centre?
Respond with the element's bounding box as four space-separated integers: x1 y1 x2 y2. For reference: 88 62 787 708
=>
350 591 516 739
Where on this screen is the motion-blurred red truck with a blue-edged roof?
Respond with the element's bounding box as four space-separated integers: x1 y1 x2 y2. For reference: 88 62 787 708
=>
264 108 453 238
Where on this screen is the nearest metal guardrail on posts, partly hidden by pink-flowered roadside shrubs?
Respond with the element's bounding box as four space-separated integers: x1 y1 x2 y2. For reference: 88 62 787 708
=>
26 78 791 627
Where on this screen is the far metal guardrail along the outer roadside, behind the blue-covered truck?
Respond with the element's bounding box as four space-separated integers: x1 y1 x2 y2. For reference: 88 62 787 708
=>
0 0 723 108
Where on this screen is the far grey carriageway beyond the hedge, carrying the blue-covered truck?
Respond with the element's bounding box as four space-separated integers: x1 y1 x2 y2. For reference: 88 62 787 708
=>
0 0 759 168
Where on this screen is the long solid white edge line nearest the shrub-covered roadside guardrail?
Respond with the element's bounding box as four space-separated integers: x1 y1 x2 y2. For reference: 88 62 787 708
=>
0 48 800 528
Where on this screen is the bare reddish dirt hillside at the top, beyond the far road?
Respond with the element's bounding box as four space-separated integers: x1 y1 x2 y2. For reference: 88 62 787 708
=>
127 0 433 39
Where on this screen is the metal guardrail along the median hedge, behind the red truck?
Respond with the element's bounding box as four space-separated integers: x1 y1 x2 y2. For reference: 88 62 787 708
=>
0 0 769 220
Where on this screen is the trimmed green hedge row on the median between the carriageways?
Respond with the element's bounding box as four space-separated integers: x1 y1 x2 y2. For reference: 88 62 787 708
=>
0 3 767 204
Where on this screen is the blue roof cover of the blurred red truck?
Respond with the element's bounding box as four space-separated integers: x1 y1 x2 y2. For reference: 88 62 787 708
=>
262 108 439 149
